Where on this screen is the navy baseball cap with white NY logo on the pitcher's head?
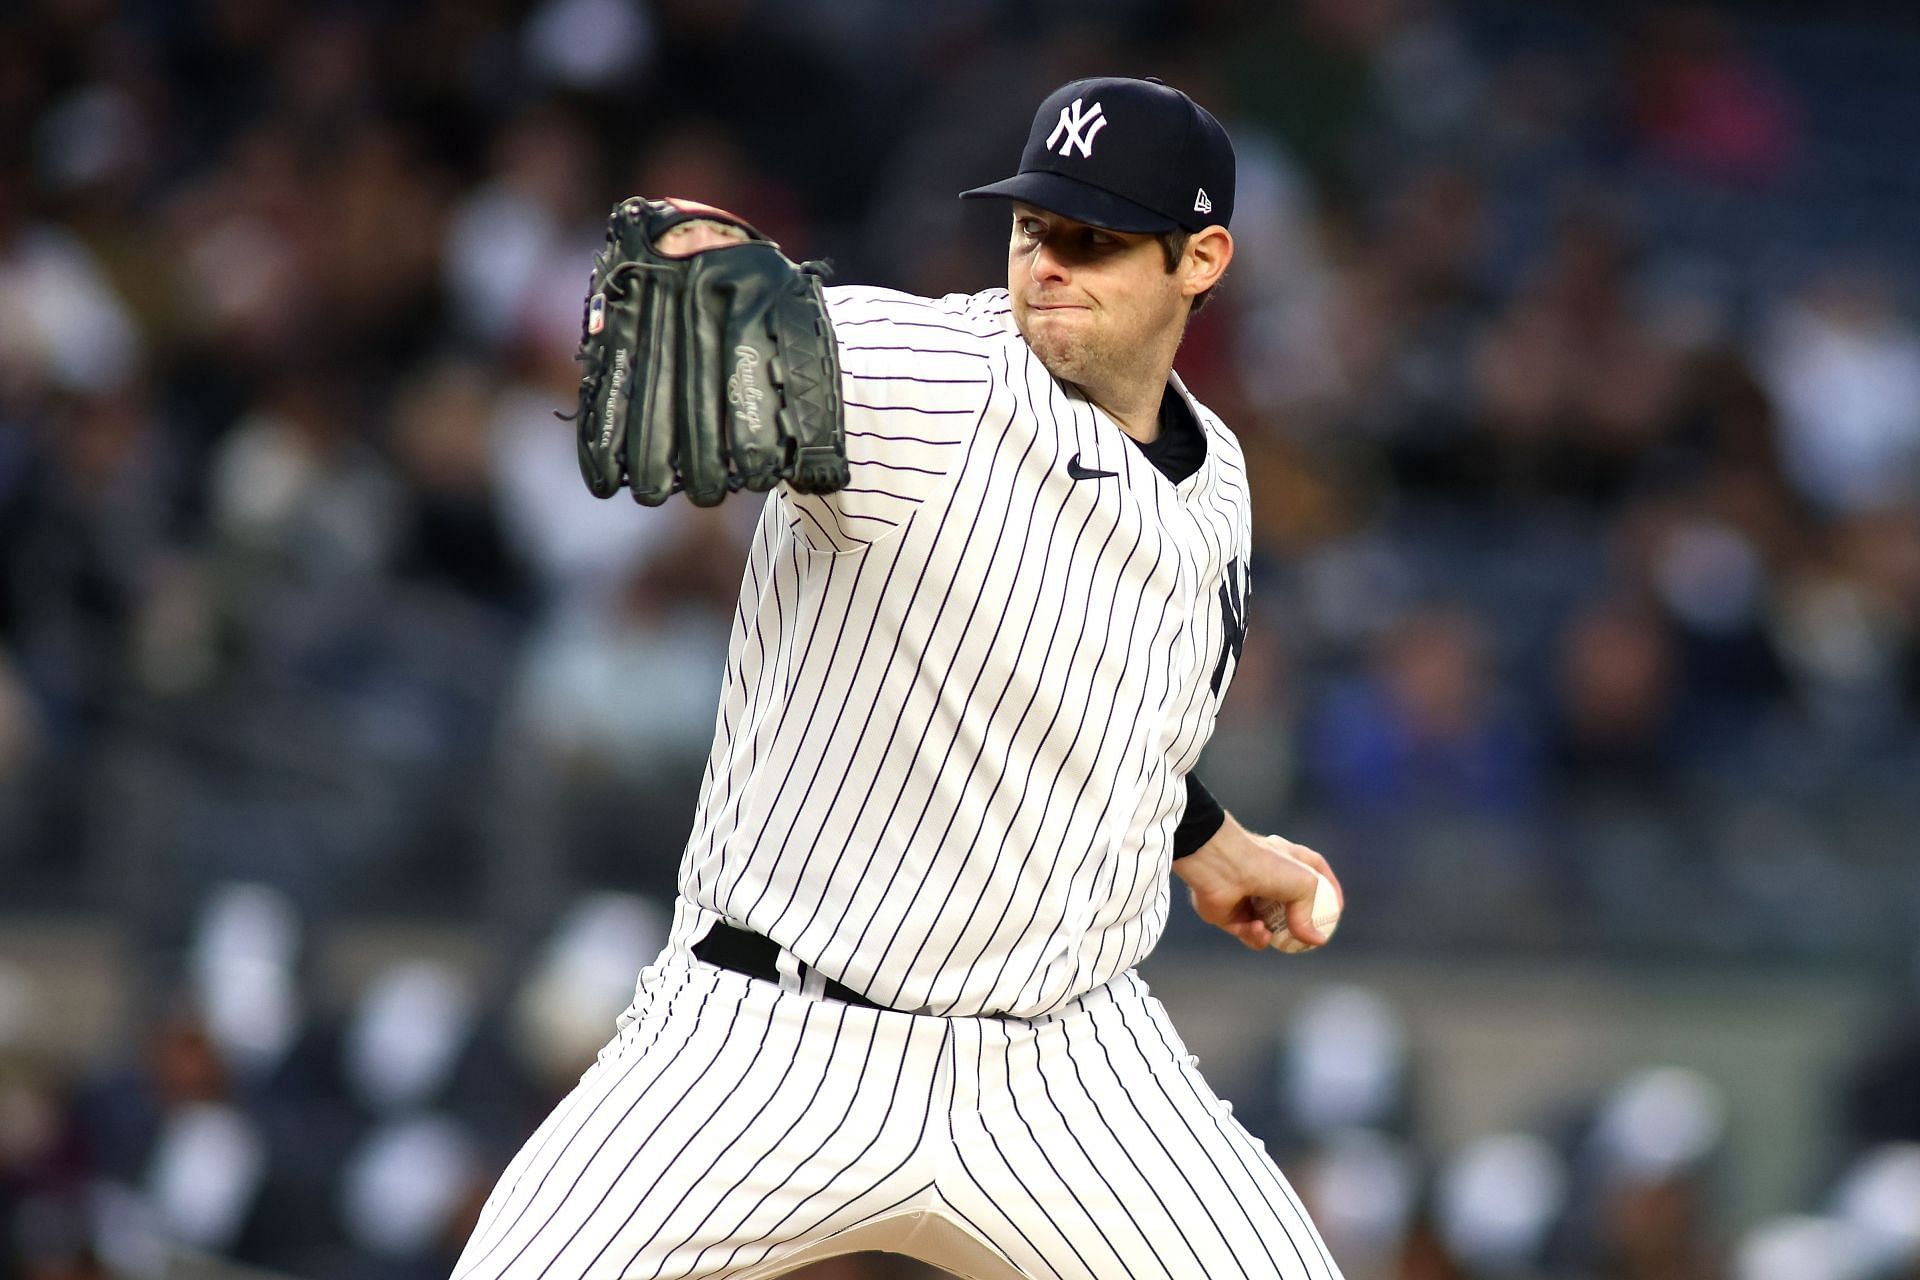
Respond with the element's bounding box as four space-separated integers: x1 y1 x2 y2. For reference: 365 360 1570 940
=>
960 75 1233 232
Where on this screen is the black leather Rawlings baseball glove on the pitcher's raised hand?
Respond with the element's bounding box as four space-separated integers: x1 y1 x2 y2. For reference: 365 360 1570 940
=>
574 196 847 507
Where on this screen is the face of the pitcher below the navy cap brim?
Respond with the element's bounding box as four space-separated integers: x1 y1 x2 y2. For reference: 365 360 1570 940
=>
1006 203 1187 390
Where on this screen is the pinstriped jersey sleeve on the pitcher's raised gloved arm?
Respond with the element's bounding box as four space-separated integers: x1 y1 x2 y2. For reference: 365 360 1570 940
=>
780 286 1008 553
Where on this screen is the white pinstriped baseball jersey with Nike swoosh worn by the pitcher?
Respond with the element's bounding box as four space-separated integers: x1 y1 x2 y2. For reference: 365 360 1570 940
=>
674 288 1250 1017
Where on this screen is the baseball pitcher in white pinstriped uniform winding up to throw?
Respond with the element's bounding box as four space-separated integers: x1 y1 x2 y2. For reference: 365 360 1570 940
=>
455 79 1340 1280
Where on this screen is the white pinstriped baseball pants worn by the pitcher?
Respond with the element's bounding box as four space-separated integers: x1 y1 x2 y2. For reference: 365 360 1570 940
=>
453 956 1340 1280
